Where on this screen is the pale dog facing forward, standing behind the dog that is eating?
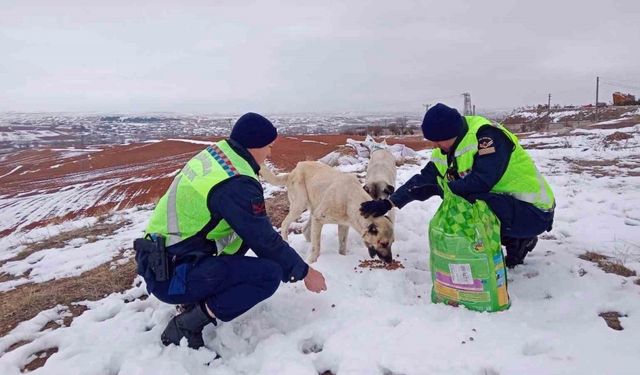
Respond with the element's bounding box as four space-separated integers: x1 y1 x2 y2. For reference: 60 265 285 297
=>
364 148 397 222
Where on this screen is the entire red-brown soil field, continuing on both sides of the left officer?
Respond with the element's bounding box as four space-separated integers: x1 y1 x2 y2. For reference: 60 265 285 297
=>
0 135 430 235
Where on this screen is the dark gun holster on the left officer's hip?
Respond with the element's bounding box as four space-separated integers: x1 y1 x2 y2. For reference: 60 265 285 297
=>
133 233 171 281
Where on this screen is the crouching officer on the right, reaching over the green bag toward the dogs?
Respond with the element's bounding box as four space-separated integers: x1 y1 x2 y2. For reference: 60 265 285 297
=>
361 103 555 268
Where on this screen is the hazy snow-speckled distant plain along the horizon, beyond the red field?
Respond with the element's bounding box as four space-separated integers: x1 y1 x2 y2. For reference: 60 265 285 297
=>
0 113 421 155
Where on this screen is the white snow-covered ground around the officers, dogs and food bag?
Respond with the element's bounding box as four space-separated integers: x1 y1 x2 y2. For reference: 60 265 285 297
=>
0 125 640 375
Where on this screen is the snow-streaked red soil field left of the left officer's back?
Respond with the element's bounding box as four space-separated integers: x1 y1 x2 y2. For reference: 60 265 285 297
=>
0 141 215 235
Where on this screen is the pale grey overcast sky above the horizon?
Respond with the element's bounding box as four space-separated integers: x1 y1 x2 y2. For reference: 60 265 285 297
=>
0 0 640 113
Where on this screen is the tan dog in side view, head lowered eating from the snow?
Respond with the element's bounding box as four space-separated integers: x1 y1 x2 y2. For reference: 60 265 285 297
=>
260 161 394 263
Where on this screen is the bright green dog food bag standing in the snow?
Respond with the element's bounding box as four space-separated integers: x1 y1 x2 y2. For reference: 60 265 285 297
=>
429 179 510 311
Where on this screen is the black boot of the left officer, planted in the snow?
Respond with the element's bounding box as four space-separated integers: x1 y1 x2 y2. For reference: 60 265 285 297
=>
160 304 218 349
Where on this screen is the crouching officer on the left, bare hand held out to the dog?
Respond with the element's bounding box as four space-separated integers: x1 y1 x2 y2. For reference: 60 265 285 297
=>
134 113 326 348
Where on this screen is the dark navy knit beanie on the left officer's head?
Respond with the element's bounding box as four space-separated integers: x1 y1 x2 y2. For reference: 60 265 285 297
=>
229 112 278 148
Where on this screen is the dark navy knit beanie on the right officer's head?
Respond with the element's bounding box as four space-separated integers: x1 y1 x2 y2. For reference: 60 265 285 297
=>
422 103 463 142
